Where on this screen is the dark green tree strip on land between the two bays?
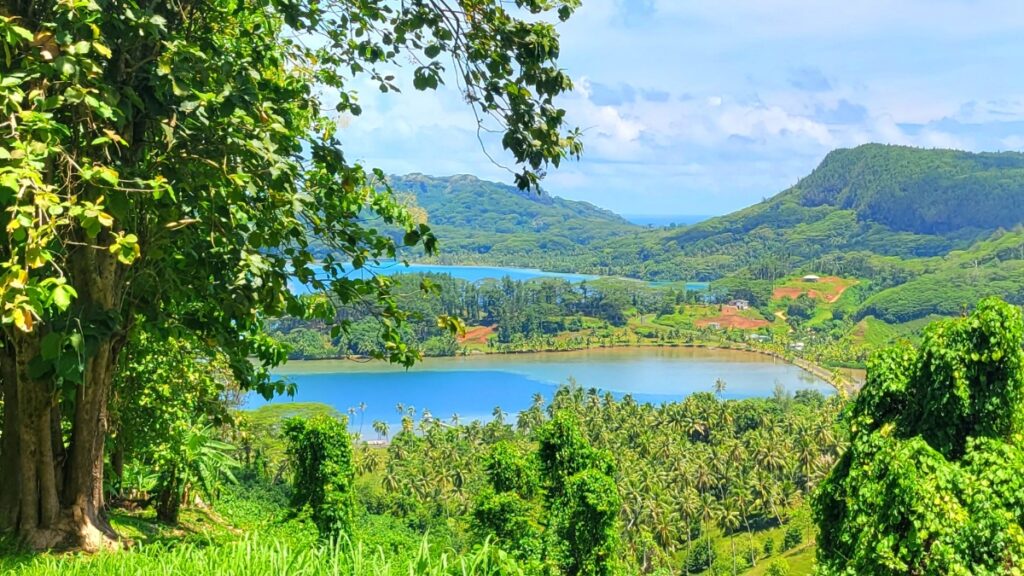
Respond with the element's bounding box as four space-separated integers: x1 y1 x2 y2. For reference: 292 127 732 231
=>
272 274 671 359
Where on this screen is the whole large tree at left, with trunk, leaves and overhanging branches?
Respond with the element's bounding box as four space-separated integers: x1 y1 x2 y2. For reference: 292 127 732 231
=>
0 0 582 549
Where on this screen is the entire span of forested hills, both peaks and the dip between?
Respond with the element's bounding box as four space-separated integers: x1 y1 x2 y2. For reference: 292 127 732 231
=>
391 145 1024 281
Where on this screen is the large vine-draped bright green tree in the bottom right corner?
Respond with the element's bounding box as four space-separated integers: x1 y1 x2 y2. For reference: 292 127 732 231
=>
814 299 1024 574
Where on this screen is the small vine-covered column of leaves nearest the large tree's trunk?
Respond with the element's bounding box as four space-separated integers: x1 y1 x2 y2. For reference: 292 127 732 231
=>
284 416 355 538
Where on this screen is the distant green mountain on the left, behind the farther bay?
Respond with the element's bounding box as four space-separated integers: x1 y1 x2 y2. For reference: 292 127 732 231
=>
389 174 642 258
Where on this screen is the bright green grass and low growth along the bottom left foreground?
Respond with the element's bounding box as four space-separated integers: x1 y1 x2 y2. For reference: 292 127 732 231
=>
0 479 522 576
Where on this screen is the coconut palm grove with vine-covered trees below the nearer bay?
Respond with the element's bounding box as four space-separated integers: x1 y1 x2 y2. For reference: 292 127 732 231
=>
356 386 844 573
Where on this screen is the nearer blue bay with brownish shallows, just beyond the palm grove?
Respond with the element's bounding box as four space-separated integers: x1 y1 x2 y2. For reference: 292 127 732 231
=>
249 348 831 426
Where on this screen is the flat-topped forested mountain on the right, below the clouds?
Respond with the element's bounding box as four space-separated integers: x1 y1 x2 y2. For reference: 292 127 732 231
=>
669 145 1024 258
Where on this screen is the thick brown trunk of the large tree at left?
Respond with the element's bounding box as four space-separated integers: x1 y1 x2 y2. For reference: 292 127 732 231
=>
0 249 122 551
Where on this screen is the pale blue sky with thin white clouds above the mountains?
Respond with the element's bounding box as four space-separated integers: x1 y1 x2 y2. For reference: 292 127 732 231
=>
341 0 1024 214
